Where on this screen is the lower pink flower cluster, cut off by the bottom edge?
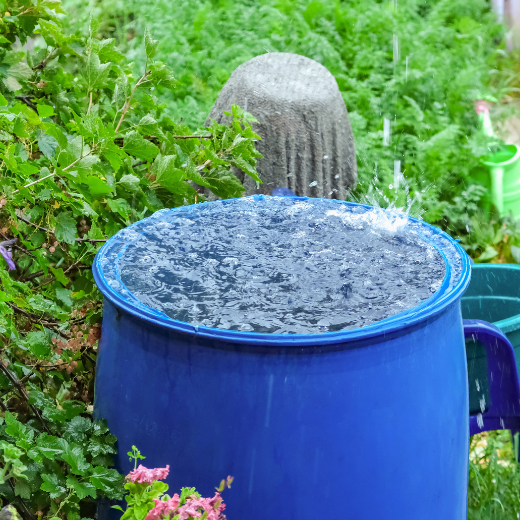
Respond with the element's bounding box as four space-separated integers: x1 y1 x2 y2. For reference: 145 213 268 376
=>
144 493 226 520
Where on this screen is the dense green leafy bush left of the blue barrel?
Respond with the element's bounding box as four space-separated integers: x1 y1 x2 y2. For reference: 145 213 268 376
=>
0 0 259 520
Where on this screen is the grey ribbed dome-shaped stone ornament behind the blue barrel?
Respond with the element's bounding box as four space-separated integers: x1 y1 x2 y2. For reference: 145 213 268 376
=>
206 52 357 199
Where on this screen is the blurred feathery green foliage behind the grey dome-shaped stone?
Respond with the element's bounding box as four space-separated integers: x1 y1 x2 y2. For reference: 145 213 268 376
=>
67 0 516 251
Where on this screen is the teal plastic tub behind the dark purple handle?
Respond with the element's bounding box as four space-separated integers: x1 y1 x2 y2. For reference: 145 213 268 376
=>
461 264 520 414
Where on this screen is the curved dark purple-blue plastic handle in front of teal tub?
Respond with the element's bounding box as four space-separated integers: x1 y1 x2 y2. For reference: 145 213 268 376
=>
463 320 520 435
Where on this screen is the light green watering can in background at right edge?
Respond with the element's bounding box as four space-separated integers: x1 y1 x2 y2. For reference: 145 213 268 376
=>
475 100 520 219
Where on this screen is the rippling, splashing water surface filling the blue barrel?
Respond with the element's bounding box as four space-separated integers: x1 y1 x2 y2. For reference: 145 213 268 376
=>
101 197 450 334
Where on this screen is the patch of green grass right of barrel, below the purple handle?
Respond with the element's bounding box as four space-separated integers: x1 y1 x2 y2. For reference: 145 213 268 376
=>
468 430 520 520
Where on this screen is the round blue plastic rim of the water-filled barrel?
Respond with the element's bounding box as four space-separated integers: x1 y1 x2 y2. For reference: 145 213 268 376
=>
92 195 471 347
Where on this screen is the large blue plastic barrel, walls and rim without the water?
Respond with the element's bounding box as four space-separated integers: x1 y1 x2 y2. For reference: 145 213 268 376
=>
94 197 470 520
